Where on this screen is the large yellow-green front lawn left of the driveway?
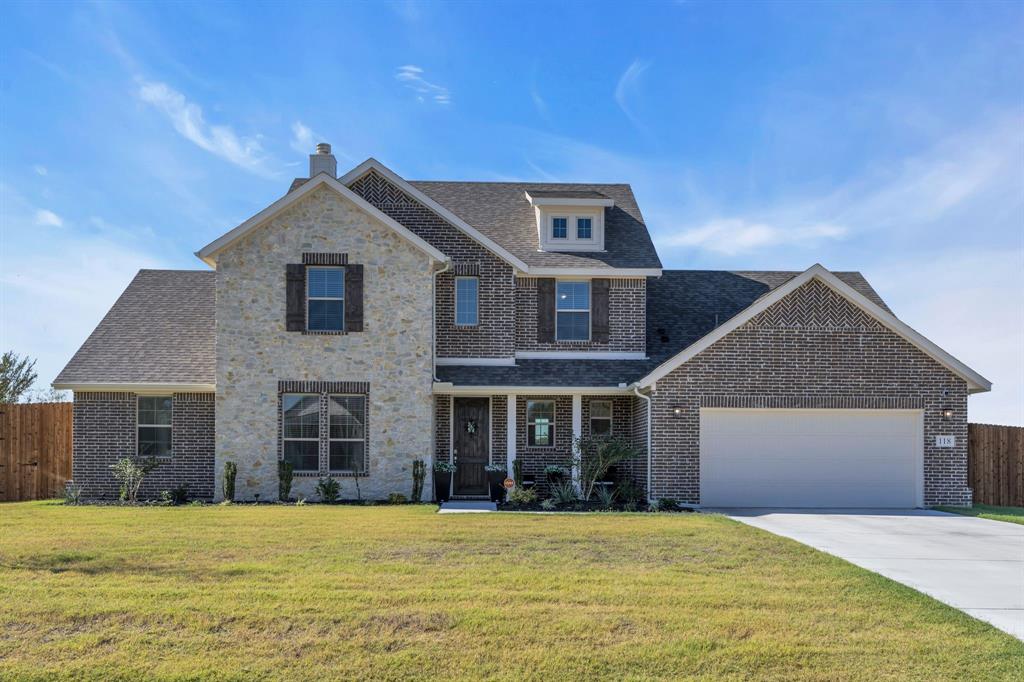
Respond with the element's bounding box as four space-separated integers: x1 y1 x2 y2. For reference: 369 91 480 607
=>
0 503 1024 681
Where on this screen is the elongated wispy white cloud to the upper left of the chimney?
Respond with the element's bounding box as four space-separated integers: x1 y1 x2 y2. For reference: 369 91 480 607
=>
138 81 278 178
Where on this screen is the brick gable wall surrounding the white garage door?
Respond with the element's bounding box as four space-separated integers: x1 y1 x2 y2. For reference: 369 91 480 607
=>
652 280 971 505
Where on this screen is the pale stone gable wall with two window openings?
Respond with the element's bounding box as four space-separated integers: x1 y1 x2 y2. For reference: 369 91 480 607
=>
216 187 433 500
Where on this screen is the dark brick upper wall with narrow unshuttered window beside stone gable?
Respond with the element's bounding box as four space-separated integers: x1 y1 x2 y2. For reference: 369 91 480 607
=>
351 171 515 357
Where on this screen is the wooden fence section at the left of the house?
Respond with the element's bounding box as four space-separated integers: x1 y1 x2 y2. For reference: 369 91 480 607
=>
0 402 72 502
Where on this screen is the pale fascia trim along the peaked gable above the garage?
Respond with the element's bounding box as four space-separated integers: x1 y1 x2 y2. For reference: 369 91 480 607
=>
637 263 992 393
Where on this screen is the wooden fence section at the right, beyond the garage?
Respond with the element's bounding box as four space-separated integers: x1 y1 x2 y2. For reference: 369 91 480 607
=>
968 424 1024 507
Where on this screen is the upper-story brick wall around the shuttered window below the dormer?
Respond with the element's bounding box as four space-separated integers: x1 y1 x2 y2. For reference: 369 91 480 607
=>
515 278 647 353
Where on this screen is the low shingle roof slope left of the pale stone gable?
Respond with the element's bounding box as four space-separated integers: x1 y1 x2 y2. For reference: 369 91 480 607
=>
54 270 216 384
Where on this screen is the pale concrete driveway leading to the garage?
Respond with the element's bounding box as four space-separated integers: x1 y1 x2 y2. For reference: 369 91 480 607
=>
720 509 1024 639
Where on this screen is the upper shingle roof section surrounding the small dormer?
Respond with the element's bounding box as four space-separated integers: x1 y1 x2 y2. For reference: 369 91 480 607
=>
410 181 662 268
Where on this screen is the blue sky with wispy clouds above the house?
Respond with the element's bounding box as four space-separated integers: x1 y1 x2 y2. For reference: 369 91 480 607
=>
0 1 1024 424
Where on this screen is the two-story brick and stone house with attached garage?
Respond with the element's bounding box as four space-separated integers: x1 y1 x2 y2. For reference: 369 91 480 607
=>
54 144 990 507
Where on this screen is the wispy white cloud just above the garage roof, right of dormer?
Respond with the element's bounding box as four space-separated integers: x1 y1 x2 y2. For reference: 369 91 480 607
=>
662 218 847 256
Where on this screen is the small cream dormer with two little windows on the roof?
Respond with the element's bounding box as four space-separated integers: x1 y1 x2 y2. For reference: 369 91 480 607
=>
525 189 615 251
